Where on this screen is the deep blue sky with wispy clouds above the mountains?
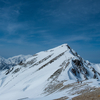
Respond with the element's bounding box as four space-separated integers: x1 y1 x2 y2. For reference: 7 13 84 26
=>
0 0 100 63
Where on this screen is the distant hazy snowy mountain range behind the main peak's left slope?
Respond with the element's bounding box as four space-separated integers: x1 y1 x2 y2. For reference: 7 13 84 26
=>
0 55 32 70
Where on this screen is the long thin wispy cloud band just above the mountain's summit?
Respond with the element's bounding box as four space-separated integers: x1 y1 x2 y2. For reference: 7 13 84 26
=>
37 31 93 45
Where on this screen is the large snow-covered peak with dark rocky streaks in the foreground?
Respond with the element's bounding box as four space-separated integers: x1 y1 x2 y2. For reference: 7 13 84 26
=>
0 44 100 100
